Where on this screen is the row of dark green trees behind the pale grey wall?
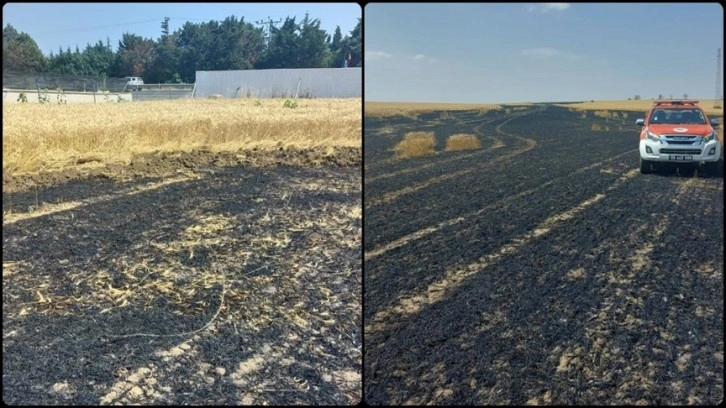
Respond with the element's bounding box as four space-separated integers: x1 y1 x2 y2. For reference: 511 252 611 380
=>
3 14 362 83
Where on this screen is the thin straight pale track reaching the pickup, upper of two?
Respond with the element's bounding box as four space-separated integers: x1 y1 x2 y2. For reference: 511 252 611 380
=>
364 149 638 261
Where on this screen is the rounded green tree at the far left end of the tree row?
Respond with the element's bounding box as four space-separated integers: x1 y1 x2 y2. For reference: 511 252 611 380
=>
3 24 47 72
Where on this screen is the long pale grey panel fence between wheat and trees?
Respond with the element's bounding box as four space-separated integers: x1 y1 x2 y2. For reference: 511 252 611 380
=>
194 68 363 98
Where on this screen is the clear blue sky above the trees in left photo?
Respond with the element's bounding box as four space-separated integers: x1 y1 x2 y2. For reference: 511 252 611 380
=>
3 3 362 55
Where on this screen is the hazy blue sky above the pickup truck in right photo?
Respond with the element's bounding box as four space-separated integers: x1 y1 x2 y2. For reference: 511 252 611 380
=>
364 3 724 103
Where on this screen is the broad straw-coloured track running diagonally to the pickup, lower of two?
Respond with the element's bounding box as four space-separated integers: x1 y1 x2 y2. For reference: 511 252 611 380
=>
366 169 639 334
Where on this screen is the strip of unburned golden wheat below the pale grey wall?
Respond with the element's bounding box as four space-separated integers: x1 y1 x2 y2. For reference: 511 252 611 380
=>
3 98 362 175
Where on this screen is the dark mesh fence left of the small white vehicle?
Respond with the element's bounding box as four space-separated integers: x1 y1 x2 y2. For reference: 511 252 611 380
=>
3 71 127 92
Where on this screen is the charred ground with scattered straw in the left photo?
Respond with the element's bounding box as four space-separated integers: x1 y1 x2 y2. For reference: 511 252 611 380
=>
3 149 362 405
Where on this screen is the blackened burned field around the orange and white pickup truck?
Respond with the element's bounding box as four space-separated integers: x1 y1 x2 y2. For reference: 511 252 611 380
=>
363 105 724 405
